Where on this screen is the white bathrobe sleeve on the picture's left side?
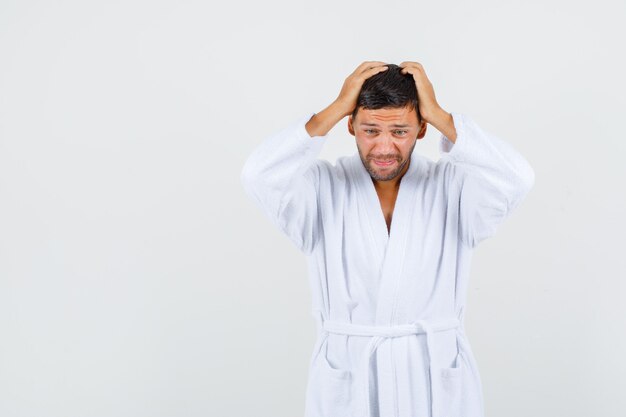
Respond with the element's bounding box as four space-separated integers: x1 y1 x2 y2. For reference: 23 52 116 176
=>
241 113 327 254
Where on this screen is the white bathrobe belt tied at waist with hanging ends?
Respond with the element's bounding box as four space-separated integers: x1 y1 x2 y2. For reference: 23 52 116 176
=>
323 318 461 417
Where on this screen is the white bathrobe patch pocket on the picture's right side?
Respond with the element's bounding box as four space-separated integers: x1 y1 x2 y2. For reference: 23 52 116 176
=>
432 356 465 417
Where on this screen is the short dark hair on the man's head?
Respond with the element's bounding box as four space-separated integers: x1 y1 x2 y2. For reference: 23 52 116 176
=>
352 64 422 121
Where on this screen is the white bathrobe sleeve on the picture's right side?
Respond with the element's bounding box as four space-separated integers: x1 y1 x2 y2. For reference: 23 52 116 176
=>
439 113 535 248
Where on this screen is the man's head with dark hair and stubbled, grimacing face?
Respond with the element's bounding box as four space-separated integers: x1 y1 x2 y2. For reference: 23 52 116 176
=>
348 64 426 181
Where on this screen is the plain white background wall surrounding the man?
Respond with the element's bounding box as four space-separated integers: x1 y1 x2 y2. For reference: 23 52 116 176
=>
0 0 626 417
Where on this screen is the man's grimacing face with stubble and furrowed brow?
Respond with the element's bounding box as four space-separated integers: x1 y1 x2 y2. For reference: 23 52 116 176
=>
348 106 426 181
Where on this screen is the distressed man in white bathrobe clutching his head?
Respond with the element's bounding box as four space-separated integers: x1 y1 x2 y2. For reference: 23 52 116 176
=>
242 62 534 417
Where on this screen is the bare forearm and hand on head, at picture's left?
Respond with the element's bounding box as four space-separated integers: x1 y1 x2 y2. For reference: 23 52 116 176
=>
305 61 388 136
